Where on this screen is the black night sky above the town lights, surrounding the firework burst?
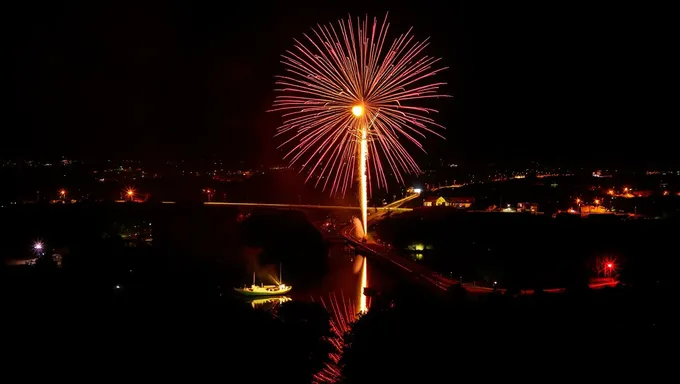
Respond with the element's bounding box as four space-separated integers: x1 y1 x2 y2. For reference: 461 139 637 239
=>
6 1 678 163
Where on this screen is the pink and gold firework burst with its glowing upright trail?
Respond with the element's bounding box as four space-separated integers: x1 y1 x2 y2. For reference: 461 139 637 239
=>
272 16 446 236
